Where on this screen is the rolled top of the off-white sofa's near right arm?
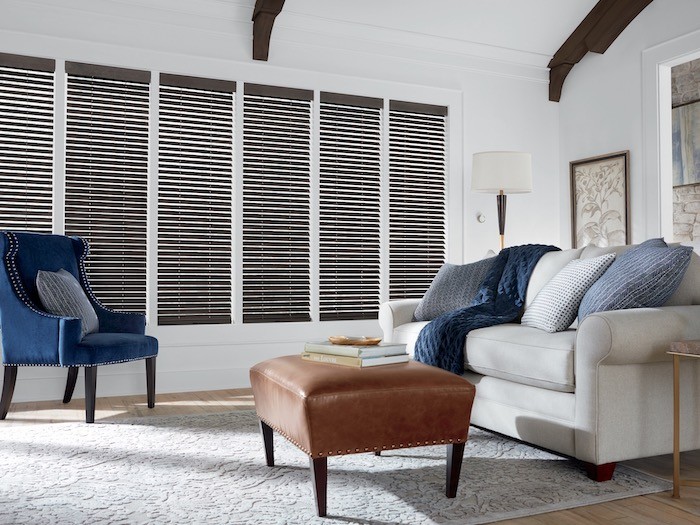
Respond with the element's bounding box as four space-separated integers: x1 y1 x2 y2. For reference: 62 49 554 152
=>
576 305 700 371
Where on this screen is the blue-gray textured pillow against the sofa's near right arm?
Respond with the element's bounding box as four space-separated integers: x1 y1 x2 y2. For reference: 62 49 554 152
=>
578 239 693 322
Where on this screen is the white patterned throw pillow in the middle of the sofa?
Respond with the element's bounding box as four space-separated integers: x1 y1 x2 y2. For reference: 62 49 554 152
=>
521 253 615 332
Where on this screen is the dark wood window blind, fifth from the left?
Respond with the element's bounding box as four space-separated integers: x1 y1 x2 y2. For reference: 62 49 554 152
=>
319 93 382 321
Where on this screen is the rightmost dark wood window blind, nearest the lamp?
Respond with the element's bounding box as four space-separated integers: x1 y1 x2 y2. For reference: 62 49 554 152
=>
389 100 447 299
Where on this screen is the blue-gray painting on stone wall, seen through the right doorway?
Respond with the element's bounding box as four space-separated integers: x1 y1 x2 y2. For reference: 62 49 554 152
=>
672 101 700 186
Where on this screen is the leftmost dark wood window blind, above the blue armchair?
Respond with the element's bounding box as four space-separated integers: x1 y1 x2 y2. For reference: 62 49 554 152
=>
0 53 55 232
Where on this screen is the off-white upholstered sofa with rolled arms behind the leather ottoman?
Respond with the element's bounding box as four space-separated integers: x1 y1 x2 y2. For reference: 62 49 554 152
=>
379 246 700 481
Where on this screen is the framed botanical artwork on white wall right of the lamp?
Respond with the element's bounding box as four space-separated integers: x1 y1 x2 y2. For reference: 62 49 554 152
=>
570 151 630 248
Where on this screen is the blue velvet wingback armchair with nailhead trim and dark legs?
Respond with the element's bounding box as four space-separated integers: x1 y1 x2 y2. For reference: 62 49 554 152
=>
0 232 158 423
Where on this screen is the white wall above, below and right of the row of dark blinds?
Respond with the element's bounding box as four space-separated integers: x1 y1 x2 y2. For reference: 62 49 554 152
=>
0 0 566 401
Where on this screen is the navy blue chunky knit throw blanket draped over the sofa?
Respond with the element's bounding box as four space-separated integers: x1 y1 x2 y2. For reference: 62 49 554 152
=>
415 244 559 374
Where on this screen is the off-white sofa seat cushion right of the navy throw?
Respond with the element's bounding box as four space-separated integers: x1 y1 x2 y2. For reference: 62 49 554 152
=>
464 323 576 392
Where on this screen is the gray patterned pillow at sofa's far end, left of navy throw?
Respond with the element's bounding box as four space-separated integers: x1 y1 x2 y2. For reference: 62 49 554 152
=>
413 258 493 321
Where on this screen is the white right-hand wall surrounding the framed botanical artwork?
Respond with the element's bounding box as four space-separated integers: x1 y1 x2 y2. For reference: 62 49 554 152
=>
559 0 700 246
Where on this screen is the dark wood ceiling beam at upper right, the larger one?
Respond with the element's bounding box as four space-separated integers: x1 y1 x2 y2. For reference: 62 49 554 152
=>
548 0 652 102
